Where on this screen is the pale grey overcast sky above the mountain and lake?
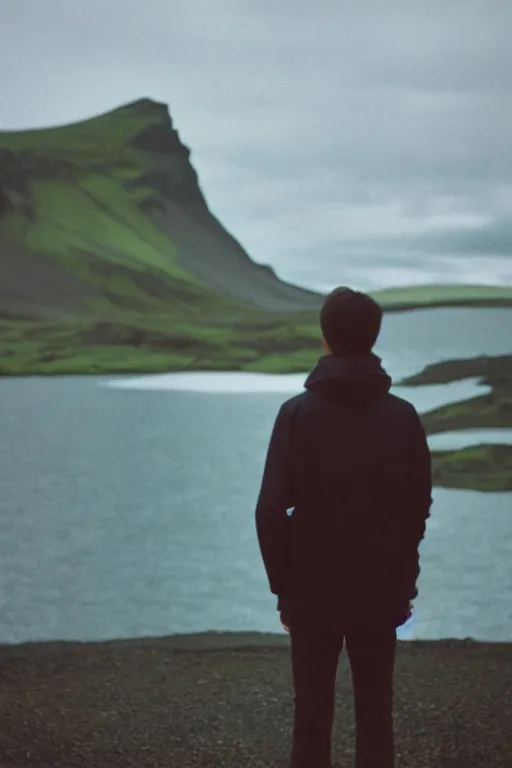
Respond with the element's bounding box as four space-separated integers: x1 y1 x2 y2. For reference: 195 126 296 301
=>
0 0 512 290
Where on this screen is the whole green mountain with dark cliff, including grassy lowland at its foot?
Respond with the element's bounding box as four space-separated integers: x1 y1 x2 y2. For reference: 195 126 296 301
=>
0 100 321 375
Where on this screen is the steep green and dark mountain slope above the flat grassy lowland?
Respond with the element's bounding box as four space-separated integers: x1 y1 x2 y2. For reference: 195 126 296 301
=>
0 100 321 316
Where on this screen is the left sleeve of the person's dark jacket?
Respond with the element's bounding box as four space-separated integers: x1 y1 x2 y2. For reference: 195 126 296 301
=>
256 403 295 595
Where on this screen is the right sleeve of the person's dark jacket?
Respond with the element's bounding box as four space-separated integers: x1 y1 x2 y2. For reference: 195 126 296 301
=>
403 411 433 600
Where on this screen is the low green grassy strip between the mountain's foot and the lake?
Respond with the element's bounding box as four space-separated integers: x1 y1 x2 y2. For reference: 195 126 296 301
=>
0 312 322 375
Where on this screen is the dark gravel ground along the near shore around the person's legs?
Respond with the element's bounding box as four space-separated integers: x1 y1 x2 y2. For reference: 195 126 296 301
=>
0 633 512 768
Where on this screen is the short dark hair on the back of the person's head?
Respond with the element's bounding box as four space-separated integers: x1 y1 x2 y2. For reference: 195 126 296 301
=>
320 287 382 357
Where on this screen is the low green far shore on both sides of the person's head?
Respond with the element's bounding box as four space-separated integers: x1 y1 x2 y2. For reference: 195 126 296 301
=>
0 284 512 377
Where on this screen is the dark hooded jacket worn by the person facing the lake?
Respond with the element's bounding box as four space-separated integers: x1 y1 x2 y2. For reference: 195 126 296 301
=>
256 353 432 626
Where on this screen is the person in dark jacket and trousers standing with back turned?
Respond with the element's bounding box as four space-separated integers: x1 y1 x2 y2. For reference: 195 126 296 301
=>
255 287 432 768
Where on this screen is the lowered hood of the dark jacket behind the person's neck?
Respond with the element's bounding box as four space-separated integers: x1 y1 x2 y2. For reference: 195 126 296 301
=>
304 352 392 404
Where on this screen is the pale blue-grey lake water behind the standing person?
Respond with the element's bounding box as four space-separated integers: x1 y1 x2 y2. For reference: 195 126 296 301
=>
0 309 512 642
